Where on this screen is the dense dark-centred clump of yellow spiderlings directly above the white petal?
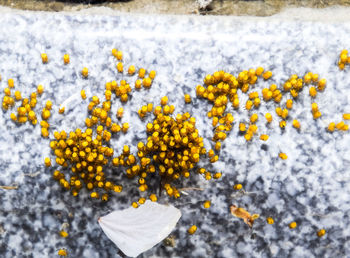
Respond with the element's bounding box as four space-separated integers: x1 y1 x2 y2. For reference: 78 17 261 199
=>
119 104 221 200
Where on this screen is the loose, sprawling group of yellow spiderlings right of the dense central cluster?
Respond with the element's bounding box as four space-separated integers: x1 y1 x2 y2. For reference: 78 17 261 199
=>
196 67 326 144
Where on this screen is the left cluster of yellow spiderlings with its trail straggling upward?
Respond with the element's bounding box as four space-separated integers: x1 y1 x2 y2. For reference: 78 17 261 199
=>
38 49 159 202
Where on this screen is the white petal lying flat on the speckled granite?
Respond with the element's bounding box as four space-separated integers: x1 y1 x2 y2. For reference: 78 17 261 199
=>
98 200 181 257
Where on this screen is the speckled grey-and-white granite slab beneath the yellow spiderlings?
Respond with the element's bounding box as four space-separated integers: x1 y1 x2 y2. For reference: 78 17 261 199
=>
0 9 350 257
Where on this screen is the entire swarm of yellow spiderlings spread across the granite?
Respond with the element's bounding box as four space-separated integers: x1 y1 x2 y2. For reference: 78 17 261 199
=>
2 49 350 211
